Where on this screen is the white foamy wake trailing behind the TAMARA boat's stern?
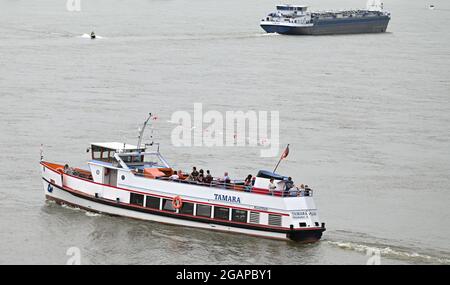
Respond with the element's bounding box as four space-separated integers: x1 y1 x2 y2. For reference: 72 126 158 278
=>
327 241 450 264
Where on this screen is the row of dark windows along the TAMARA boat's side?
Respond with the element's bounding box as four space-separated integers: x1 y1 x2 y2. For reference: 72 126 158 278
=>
130 193 281 226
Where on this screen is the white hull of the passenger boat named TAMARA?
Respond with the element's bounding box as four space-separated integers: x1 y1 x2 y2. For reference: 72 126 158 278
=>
41 159 325 242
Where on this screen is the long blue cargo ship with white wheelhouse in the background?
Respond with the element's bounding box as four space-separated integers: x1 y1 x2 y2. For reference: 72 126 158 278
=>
260 0 391 35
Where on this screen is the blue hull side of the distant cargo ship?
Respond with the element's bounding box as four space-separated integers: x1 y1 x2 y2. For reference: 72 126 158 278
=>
261 17 390 35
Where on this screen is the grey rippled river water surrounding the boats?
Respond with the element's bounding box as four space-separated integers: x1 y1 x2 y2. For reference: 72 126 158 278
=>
0 0 450 264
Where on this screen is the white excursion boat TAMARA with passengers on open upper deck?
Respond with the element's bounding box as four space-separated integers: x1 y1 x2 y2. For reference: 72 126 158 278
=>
40 116 325 242
